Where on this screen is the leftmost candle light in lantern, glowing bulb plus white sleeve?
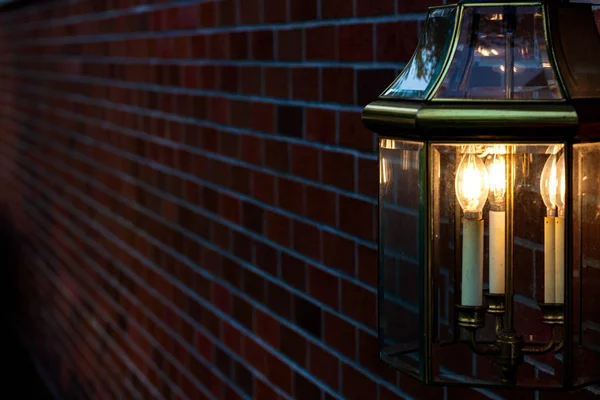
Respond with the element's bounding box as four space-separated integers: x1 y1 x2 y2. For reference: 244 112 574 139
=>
455 147 489 306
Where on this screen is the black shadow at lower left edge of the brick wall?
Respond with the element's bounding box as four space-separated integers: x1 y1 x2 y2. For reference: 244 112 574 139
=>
0 207 54 400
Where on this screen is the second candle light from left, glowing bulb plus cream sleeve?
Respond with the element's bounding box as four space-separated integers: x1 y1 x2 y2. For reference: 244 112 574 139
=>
487 145 506 294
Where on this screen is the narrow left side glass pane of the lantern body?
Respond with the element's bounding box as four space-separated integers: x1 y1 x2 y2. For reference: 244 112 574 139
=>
379 139 423 375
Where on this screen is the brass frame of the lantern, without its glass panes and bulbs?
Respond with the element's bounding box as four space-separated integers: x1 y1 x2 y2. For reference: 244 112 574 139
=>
362 0 600 389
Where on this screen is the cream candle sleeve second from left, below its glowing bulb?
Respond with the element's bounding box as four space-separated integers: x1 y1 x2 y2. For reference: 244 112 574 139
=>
489 211 506 294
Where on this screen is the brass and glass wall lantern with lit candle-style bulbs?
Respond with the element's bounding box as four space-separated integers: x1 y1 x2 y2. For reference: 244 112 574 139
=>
363 0 600 388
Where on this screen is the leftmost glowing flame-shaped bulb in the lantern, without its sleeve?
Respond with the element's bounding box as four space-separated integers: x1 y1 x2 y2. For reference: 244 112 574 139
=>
455 153 489 219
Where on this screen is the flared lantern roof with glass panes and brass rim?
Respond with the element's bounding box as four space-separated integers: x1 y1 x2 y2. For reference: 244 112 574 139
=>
363 0 600 141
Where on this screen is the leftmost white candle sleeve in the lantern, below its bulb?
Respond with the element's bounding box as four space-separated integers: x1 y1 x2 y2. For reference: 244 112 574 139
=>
461 219 483 306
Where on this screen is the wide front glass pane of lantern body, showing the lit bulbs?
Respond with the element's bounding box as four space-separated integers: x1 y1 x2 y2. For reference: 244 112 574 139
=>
430 143 565 387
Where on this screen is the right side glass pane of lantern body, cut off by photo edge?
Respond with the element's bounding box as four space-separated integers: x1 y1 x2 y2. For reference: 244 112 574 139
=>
572 143 600 385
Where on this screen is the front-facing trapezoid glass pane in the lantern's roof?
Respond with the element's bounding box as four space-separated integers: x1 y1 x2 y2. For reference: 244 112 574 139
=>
435 6 562 100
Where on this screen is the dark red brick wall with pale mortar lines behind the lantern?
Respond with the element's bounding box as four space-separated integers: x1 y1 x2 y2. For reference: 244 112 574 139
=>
0 0 589 400
